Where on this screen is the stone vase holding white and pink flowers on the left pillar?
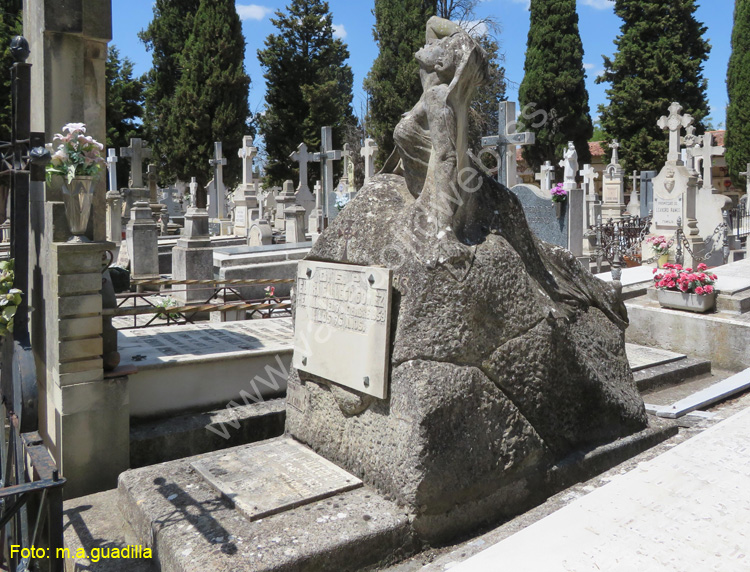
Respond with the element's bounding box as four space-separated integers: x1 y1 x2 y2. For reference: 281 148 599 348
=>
47 123 104 242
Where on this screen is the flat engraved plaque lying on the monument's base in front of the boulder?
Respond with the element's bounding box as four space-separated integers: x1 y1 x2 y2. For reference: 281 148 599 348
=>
191 437 362 520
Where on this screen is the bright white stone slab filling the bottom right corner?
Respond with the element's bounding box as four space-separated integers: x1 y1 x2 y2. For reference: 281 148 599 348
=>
450 410 750 572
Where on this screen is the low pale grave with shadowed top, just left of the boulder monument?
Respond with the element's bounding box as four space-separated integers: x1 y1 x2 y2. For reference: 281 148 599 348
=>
118 318 294 417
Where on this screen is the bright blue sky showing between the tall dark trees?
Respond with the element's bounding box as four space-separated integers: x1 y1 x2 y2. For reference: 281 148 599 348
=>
112 0 734 126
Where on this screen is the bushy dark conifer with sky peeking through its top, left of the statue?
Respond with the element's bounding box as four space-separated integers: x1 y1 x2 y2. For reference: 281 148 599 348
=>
258 0 356 185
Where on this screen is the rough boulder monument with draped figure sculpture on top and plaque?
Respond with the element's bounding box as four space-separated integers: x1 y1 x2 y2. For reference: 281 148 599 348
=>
286 17 647 542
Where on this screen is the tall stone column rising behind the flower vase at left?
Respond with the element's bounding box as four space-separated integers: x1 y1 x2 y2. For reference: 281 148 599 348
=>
25 0 112 241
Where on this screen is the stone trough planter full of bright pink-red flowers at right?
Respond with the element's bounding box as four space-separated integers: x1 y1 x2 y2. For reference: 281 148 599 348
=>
654 264 716 312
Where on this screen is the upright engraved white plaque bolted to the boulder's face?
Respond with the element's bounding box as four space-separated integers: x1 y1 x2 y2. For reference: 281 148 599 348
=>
293 260 392 399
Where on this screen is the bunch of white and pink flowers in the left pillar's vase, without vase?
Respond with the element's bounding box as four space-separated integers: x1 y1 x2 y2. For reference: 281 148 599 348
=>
47 123 104 184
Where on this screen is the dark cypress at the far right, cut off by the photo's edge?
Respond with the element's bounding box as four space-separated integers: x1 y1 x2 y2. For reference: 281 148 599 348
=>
726 0 750 188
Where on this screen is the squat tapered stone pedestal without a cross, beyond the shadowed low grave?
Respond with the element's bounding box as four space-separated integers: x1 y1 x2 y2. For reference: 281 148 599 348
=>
172 207 214 303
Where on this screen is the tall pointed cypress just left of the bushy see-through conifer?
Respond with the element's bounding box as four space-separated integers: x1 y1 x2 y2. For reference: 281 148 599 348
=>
167 0 250 201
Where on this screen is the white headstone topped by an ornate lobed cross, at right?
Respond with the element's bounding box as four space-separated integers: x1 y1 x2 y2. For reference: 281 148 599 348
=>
651 102 713 267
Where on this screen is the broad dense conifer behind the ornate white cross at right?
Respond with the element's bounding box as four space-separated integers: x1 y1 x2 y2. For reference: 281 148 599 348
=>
597 0 711 171
